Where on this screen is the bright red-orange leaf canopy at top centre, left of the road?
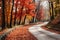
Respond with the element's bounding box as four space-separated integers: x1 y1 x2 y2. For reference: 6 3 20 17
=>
15 0 35 20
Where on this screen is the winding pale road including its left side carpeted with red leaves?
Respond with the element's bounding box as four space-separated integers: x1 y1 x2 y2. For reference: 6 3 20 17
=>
0 22 60 40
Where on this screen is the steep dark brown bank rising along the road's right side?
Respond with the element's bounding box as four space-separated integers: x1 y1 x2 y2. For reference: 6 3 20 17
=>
47 14 60 31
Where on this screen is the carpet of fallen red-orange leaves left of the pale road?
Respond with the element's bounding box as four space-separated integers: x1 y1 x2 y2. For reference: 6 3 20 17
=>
5 26 37 40
